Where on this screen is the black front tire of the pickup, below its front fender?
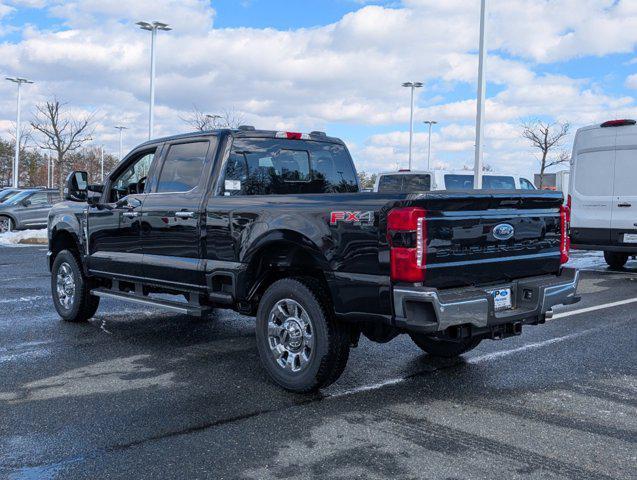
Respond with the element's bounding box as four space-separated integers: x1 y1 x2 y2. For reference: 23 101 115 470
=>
51 250 100 322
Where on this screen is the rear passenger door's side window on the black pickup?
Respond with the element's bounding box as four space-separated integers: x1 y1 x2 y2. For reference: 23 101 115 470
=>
157 141 210 193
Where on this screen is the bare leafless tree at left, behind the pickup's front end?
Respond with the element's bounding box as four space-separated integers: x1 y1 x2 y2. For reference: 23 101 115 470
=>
31 98 93 195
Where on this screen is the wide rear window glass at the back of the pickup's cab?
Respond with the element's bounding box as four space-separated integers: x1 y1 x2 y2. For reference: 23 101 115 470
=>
221 138 358 195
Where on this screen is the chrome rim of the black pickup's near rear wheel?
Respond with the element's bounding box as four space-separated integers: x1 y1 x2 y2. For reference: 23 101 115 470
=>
268 298 315 373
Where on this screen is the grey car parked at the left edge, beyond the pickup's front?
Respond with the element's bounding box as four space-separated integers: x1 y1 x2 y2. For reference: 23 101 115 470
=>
0 188 61 233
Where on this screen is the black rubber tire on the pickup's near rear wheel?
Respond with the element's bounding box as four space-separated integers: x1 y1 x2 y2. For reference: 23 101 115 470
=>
256 278 351 393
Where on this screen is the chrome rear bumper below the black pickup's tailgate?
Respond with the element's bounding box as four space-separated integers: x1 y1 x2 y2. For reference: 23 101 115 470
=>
393 268 579 333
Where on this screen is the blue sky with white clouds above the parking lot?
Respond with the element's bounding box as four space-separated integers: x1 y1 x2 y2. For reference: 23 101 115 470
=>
0 0 637 175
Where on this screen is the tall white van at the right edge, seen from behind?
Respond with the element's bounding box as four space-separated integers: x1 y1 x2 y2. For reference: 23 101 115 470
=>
569 120 637 268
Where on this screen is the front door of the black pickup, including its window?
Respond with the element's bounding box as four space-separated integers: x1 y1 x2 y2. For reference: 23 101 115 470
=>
88 146 159 278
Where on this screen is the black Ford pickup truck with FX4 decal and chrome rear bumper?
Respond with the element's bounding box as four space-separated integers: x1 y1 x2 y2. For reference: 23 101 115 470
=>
48 127 579 392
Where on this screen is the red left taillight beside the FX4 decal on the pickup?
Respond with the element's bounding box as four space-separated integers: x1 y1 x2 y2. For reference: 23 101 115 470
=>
387 207 427 283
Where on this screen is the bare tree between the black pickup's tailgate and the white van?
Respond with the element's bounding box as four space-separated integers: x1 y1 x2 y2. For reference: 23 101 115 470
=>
522 120 571 188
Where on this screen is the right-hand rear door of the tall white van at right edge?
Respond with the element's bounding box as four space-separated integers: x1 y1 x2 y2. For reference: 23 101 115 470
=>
611 145 637 244
